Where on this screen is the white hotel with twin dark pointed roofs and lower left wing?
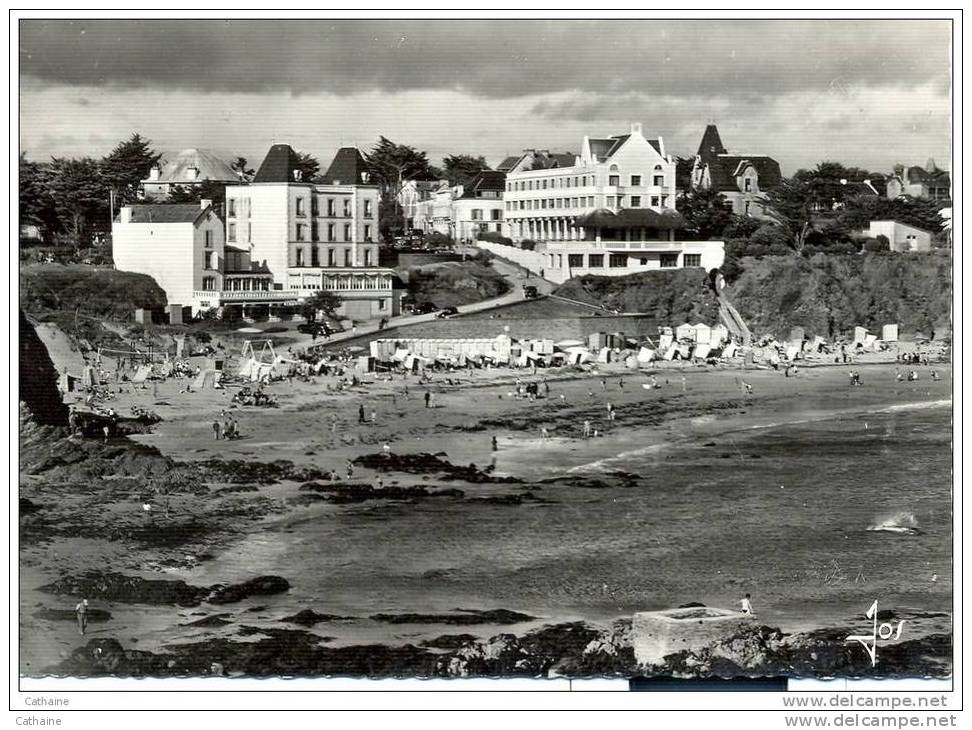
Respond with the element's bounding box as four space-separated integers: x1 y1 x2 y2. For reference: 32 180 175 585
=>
112 145 402 320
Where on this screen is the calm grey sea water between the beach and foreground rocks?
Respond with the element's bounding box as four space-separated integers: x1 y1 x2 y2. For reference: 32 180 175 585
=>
180 403 952 640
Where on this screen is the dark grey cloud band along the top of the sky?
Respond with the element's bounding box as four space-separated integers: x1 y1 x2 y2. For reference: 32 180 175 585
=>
20 20 951 101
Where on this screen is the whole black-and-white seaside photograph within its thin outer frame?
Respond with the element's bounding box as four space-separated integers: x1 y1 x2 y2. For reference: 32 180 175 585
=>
10 11 961 703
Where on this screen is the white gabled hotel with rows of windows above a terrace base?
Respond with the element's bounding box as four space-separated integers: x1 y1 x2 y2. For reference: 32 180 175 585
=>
479 124 725 283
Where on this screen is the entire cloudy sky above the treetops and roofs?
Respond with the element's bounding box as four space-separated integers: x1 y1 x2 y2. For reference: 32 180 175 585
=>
20 20 951 173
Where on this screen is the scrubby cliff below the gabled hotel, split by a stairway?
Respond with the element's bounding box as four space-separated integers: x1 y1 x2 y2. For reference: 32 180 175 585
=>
556 251 952 337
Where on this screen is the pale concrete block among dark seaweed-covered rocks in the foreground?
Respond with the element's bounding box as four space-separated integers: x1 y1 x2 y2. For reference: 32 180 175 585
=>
631 607 754 664
